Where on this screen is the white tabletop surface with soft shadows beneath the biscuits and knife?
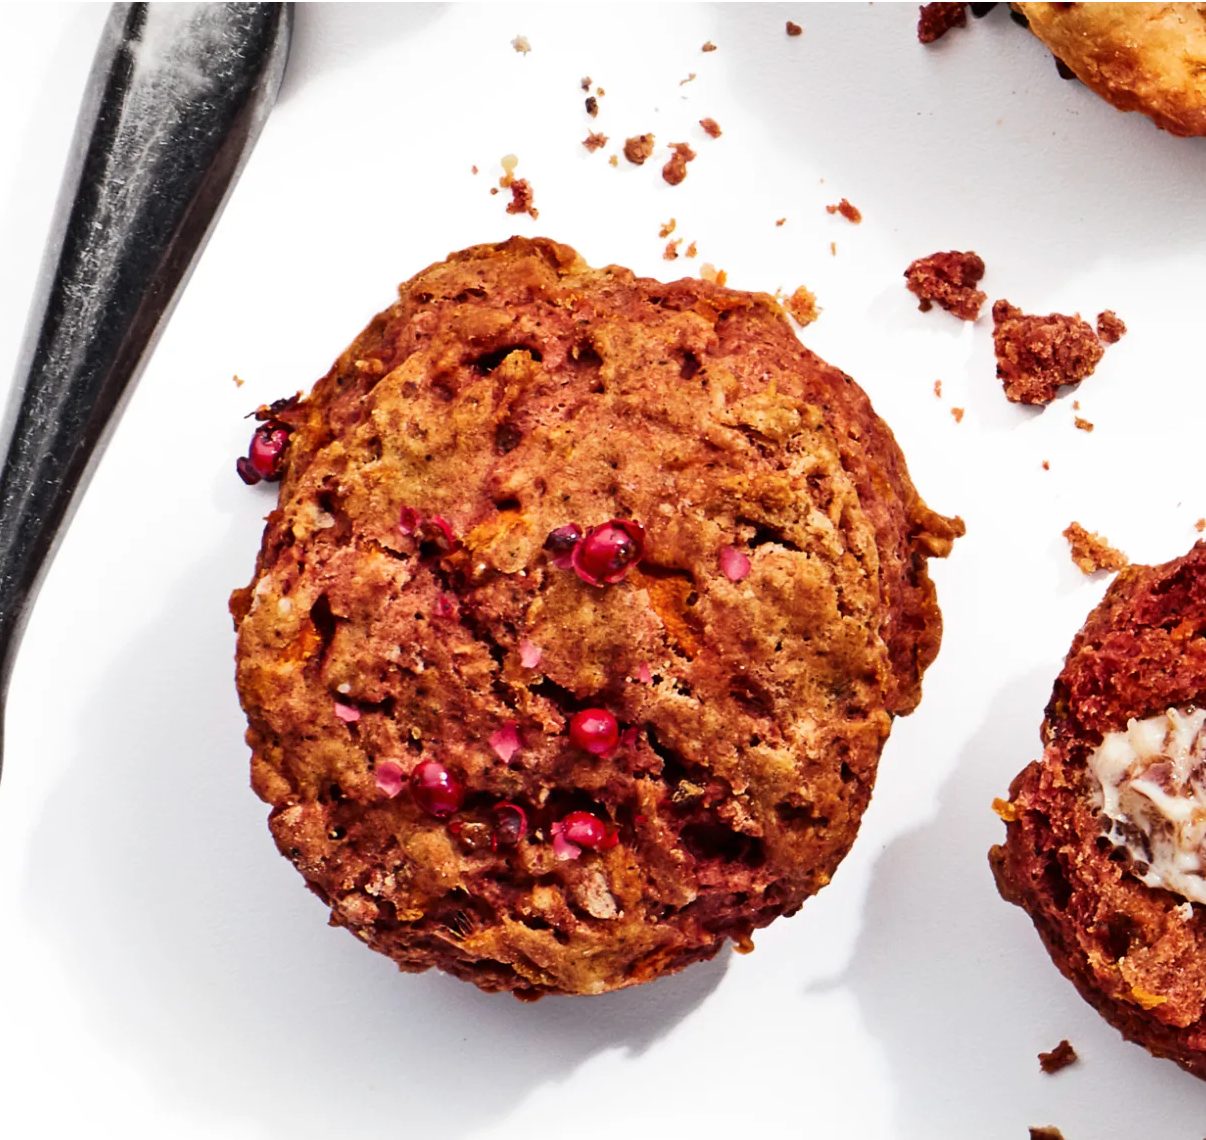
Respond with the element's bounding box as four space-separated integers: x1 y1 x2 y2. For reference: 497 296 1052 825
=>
0 4 1206 1140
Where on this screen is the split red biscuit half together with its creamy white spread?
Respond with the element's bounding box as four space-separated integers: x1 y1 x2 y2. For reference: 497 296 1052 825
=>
989 543 1206 1078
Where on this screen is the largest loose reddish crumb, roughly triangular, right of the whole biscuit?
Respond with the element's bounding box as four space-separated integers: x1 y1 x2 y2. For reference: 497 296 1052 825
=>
993 300 1105 404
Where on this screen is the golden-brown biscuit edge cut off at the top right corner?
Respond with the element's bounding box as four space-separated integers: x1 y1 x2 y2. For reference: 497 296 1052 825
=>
1013 4 1206 135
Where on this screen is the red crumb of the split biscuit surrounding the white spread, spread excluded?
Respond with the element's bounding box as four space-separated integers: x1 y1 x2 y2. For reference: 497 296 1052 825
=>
990 543 1206 1077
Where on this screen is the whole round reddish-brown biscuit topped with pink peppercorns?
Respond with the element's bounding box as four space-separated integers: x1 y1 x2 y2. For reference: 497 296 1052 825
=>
232 238 962 998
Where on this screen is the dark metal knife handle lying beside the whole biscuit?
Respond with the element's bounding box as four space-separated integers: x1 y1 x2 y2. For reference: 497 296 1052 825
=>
0 4 293 761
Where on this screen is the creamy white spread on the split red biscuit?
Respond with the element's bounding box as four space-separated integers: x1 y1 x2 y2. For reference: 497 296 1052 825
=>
1089 708 1206 904
